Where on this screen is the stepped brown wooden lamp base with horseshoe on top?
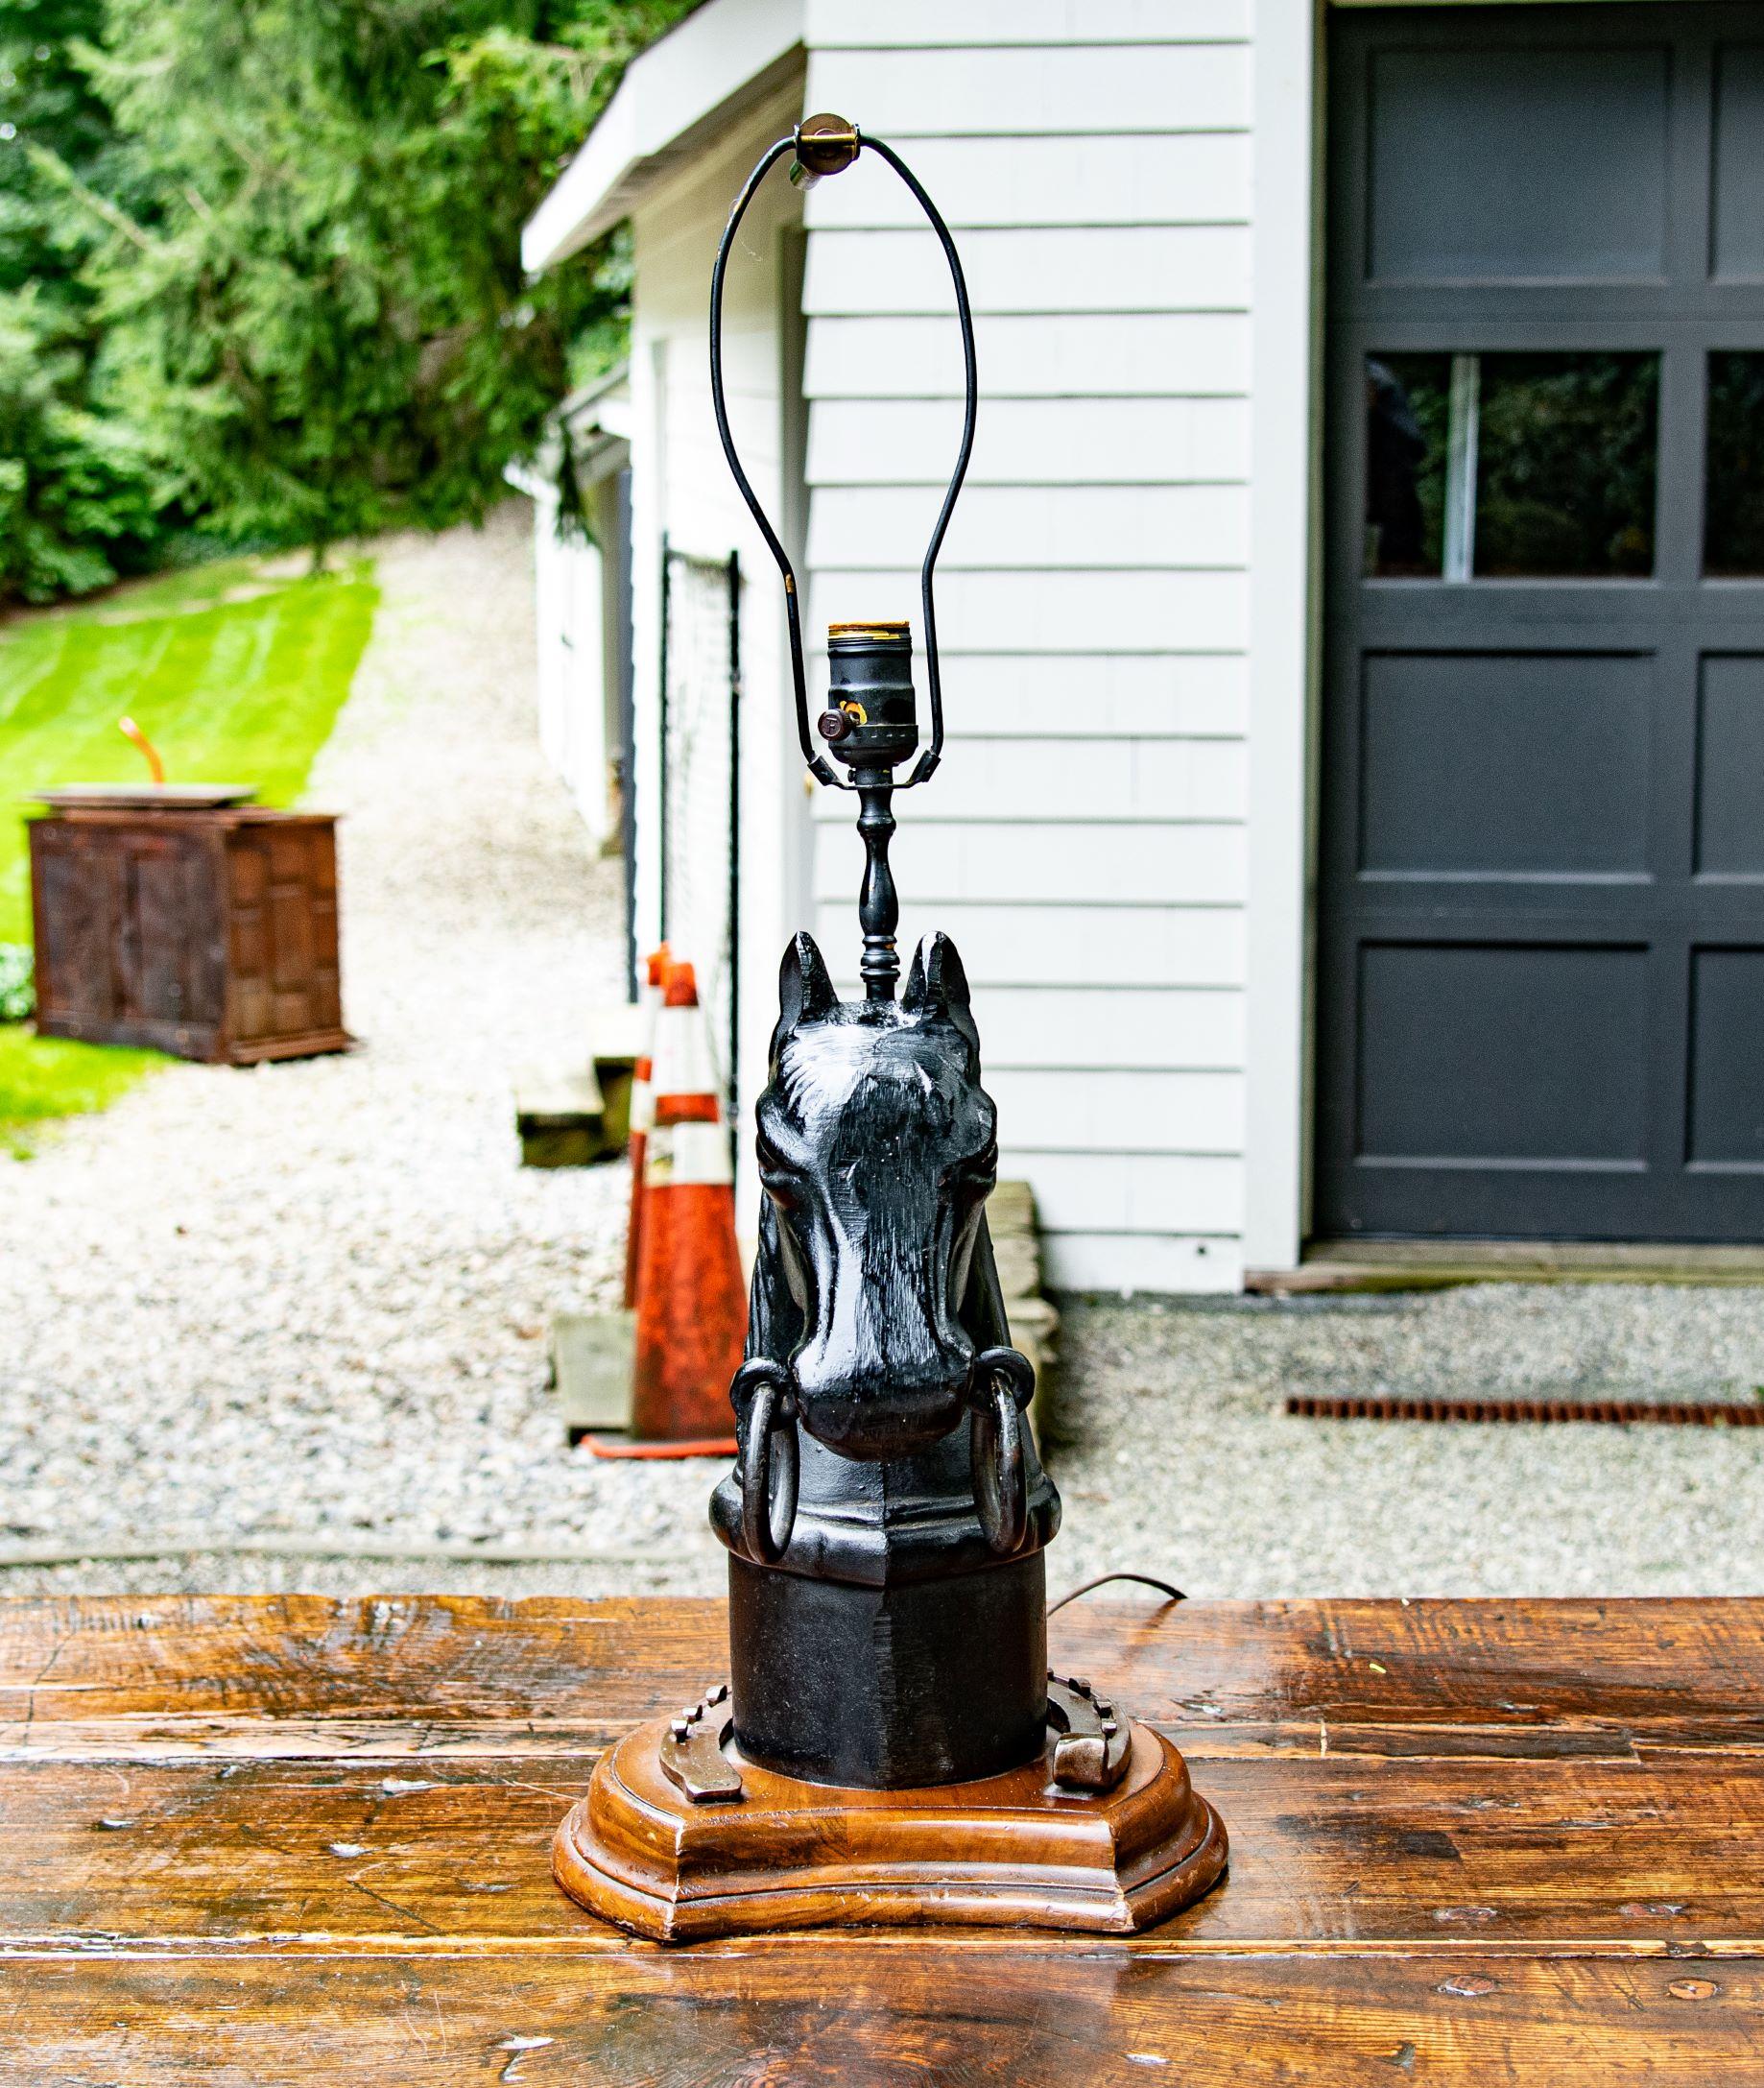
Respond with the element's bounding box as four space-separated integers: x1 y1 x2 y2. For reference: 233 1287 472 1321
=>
551 1692 1226 1942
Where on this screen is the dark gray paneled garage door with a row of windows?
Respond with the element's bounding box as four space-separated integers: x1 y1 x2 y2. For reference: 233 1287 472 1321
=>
1315 7 1764 1240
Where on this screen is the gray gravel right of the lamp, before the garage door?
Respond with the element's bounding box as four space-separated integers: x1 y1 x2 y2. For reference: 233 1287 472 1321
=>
1031 1284 1764 1599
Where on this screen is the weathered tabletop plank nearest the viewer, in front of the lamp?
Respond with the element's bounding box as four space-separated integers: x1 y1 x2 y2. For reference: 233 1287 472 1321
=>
0 1937 1764 2088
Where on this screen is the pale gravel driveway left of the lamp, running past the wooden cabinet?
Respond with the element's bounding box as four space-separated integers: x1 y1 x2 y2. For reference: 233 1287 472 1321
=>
0 503 714 1591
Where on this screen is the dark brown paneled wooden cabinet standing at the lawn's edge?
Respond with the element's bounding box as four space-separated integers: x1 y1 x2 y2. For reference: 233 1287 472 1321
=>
32 791 350 1065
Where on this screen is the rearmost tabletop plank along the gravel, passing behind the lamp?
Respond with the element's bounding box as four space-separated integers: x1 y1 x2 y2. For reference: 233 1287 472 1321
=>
0 1603 1764 1754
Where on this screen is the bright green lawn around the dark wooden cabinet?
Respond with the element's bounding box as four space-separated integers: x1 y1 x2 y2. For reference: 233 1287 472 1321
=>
0 560 378 1153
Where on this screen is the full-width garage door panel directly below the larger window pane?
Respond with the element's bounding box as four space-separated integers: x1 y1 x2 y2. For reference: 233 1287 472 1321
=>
1359 654 1654 877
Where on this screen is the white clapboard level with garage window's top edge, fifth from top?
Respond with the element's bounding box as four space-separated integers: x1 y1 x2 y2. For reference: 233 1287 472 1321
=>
803 311 1251 401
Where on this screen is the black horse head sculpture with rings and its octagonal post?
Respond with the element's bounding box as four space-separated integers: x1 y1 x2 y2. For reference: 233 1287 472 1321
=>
712 935 1059 1783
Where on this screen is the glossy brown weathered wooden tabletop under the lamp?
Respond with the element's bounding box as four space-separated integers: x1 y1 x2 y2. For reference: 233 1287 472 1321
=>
0 1596 1764 2088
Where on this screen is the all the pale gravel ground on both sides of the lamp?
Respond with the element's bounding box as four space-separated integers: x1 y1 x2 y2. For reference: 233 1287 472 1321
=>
0 505 1764 1599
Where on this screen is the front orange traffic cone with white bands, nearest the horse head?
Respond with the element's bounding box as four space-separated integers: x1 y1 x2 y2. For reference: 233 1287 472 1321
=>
588 965 748 1457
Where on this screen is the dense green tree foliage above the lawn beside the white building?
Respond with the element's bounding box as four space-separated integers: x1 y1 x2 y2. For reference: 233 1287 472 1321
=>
0 0 689 595
